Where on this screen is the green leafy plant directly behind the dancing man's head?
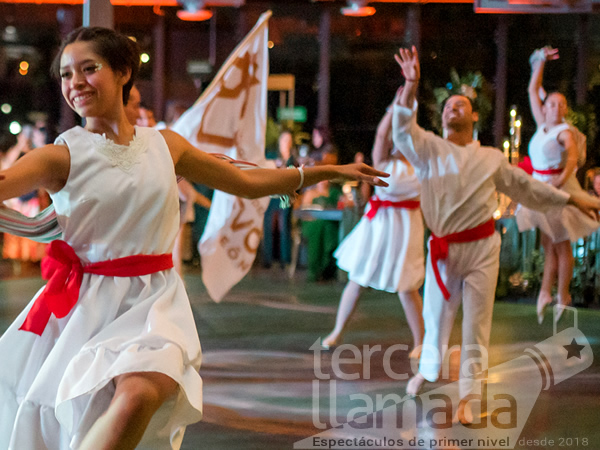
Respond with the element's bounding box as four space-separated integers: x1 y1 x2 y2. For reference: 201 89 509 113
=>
431 68 492 133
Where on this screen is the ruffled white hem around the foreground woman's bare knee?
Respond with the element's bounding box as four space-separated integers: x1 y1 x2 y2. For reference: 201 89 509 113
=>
56 342 202 449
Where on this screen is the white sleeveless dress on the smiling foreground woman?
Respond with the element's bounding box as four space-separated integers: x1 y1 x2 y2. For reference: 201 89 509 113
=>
0 127 202 450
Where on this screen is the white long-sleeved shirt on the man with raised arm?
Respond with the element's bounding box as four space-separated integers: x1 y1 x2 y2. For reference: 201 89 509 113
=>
392 104 569 236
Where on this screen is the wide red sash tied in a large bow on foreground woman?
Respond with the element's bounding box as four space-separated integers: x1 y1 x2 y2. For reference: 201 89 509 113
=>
19 240 173 336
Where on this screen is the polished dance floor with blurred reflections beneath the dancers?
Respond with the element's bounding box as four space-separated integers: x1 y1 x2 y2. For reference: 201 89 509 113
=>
0 266 600 450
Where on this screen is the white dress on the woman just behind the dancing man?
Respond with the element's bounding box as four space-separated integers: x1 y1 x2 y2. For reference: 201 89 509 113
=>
334 159 425 292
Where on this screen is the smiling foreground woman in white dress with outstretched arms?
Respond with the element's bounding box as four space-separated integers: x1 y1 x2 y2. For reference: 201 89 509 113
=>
0 28 385 450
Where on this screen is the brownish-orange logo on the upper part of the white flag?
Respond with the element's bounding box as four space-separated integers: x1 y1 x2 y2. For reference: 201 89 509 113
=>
196 53 260 151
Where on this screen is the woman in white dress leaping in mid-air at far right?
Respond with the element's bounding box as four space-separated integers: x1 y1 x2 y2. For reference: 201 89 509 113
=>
517 47 600 324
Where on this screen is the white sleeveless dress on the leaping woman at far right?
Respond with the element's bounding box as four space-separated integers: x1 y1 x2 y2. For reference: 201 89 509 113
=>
515 123 600 243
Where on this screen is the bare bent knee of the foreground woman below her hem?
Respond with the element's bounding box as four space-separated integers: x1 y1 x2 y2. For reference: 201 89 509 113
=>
80 372 178 450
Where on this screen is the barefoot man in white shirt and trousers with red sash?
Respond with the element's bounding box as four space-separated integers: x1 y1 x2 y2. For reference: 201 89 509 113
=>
393 47 600 423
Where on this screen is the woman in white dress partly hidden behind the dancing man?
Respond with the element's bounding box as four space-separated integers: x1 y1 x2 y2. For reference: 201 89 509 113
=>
322 103 425 358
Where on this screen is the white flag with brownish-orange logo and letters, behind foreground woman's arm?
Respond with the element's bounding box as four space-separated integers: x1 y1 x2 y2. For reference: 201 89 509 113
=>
173 11 271 302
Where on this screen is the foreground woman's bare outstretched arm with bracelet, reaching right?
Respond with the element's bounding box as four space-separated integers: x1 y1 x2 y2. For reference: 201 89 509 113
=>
161 126 389 198
